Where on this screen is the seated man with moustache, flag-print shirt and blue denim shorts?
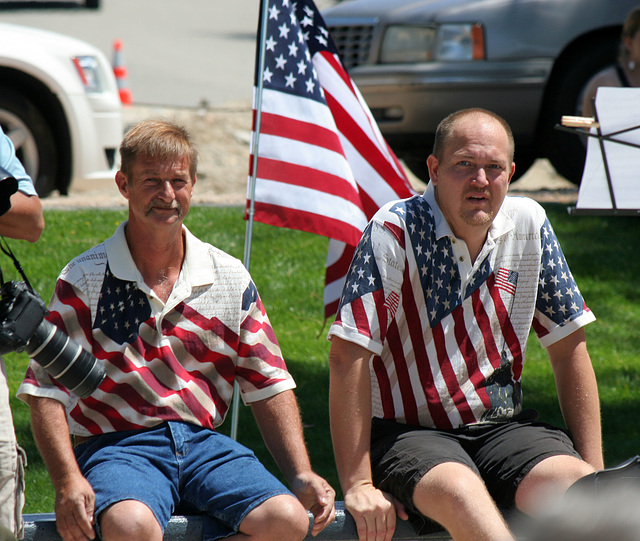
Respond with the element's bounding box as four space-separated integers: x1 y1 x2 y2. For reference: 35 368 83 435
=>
18 121 335 541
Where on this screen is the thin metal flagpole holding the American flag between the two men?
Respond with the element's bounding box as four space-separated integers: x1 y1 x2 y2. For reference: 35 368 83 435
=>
231 0 269 440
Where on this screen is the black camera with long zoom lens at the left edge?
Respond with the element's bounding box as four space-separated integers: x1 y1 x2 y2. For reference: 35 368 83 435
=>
0 281 106 398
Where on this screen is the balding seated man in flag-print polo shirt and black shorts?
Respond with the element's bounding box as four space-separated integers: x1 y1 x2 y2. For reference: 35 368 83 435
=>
329 109 603 541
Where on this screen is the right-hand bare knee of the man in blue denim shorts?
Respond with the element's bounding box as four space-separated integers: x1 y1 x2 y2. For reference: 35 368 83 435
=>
240 494 309 541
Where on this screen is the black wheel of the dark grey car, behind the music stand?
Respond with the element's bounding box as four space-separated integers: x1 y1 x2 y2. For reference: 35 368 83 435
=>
538 38 618 184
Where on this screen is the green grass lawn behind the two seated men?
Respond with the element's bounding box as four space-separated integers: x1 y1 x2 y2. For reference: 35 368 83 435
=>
5 204 640 513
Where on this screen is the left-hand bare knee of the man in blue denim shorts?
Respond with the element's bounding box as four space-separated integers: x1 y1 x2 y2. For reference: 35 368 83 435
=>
99 500 162 541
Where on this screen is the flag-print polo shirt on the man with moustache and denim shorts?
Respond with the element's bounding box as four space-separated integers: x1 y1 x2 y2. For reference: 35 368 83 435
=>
18 224 295 436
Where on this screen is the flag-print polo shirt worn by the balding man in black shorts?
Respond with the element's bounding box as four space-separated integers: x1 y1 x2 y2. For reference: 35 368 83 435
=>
329 184 595 429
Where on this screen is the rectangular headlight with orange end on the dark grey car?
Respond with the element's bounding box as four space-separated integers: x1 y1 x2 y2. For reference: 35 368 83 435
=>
380 24 484 64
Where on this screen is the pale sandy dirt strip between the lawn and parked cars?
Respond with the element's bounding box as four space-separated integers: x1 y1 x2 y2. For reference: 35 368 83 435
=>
43 104 577 208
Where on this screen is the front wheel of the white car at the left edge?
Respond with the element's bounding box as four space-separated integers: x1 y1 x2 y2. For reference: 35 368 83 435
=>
0 87 58 197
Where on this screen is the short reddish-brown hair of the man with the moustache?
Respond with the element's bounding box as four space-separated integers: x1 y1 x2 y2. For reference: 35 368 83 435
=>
120 119 198 179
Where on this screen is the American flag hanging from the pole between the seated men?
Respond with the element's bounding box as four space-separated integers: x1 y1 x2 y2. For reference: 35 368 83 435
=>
248 0 414 317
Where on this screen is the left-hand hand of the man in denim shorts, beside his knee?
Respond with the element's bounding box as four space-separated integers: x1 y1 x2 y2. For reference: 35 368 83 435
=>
56 475 96 541
